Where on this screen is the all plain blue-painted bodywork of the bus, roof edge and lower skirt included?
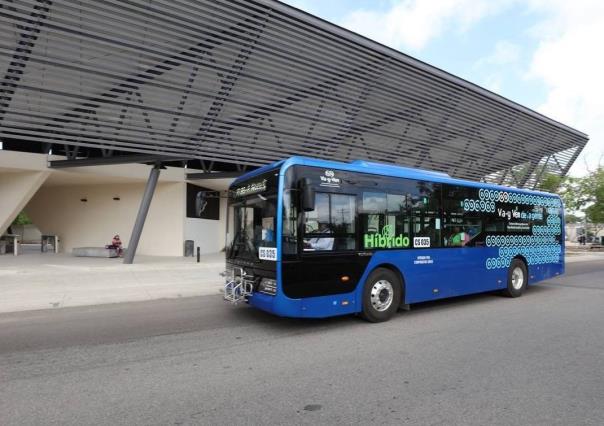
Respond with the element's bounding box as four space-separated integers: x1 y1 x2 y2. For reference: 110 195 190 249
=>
235 157 564 318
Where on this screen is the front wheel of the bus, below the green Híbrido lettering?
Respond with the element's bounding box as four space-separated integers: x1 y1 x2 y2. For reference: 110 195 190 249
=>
361 268 402 322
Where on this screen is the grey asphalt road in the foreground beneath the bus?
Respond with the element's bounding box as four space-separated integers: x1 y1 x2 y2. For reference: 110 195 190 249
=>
0 262 604 426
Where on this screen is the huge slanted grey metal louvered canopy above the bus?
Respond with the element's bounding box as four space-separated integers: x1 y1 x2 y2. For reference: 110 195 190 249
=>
0 0 587 186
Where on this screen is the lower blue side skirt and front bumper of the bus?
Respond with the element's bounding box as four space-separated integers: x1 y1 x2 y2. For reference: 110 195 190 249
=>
249 247 564 318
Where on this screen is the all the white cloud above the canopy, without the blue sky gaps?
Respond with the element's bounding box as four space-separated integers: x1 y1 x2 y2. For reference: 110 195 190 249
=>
339 0 604 174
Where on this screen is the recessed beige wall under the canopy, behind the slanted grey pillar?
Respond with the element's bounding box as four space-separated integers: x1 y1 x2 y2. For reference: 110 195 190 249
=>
25 182 185 256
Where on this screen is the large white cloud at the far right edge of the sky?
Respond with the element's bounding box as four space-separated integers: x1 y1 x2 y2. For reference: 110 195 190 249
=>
528 0 604 175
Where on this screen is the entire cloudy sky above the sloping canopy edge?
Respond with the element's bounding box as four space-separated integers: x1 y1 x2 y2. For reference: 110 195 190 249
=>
285 0 604 176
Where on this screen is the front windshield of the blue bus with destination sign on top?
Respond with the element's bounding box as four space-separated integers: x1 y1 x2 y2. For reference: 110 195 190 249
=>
226 170 277 261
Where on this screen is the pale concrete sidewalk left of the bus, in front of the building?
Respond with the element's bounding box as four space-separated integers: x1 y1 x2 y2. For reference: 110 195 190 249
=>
0 253 224 313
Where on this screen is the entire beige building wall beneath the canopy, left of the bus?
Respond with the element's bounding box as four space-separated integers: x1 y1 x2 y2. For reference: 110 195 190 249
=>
0 149 232 256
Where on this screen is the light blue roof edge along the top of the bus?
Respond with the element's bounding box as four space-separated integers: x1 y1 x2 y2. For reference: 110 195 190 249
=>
233 156 559 198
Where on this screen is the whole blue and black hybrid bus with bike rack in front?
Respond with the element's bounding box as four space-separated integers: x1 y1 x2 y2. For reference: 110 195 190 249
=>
225 157 564 322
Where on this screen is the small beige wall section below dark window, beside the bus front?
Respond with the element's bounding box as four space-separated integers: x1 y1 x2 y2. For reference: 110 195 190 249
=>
184 199 226 254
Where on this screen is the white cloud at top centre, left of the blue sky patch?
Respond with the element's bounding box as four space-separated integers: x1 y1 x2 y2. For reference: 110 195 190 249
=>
340 0 512 51
